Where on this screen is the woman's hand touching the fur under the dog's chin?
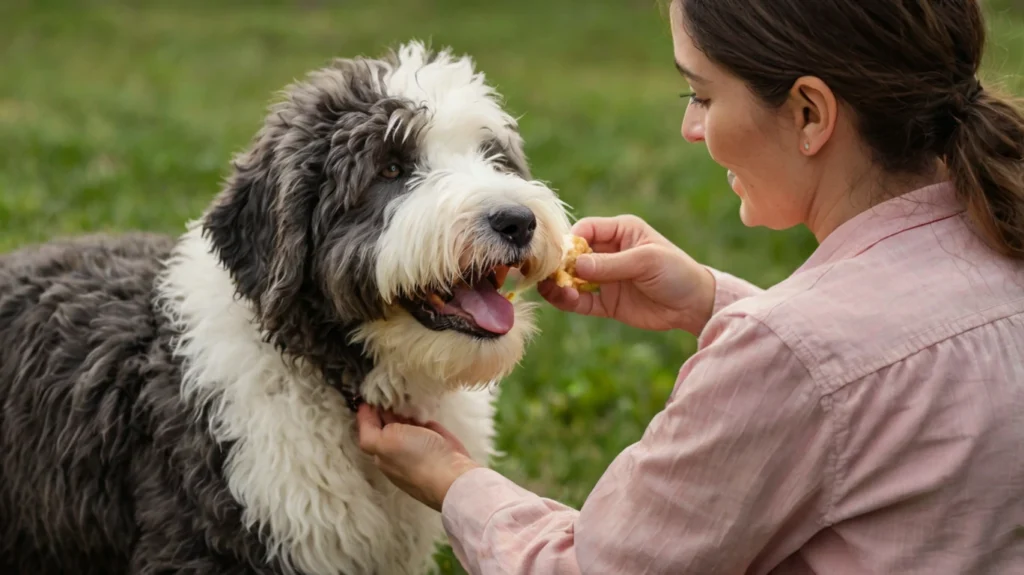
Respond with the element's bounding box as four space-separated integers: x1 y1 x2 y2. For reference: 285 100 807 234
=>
356 404 480 512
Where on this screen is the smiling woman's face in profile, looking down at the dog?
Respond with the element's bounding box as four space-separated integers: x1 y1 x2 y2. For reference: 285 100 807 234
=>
671 2 815 229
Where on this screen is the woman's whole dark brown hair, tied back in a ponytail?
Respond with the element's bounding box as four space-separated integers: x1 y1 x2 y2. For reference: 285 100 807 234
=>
675 0 1024 259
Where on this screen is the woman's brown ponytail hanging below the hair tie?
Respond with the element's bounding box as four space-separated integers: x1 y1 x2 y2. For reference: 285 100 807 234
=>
945 84 1024 260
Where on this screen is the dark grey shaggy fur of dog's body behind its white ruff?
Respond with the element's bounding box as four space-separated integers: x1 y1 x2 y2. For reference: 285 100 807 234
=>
0 230 279 575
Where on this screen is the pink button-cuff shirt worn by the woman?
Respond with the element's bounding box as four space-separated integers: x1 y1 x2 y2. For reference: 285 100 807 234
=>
442 184 1024 575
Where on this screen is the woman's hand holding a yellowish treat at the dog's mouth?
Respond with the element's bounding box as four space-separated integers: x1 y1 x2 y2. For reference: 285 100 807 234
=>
538 216 715 335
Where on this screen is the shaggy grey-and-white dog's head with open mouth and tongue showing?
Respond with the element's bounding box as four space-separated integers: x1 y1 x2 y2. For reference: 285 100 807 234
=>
203 43 569 392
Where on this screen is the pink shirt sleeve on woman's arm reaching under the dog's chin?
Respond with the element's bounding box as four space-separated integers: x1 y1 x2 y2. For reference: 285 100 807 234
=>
442 317 830 575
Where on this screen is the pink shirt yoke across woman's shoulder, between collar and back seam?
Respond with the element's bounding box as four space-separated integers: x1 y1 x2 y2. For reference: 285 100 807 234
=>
700 233 1024 391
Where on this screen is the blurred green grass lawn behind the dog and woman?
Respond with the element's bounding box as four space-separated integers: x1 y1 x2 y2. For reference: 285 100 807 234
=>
0 0 1024 573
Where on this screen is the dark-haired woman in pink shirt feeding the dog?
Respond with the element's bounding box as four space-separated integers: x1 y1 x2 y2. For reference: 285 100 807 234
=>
359 0 1024 574
